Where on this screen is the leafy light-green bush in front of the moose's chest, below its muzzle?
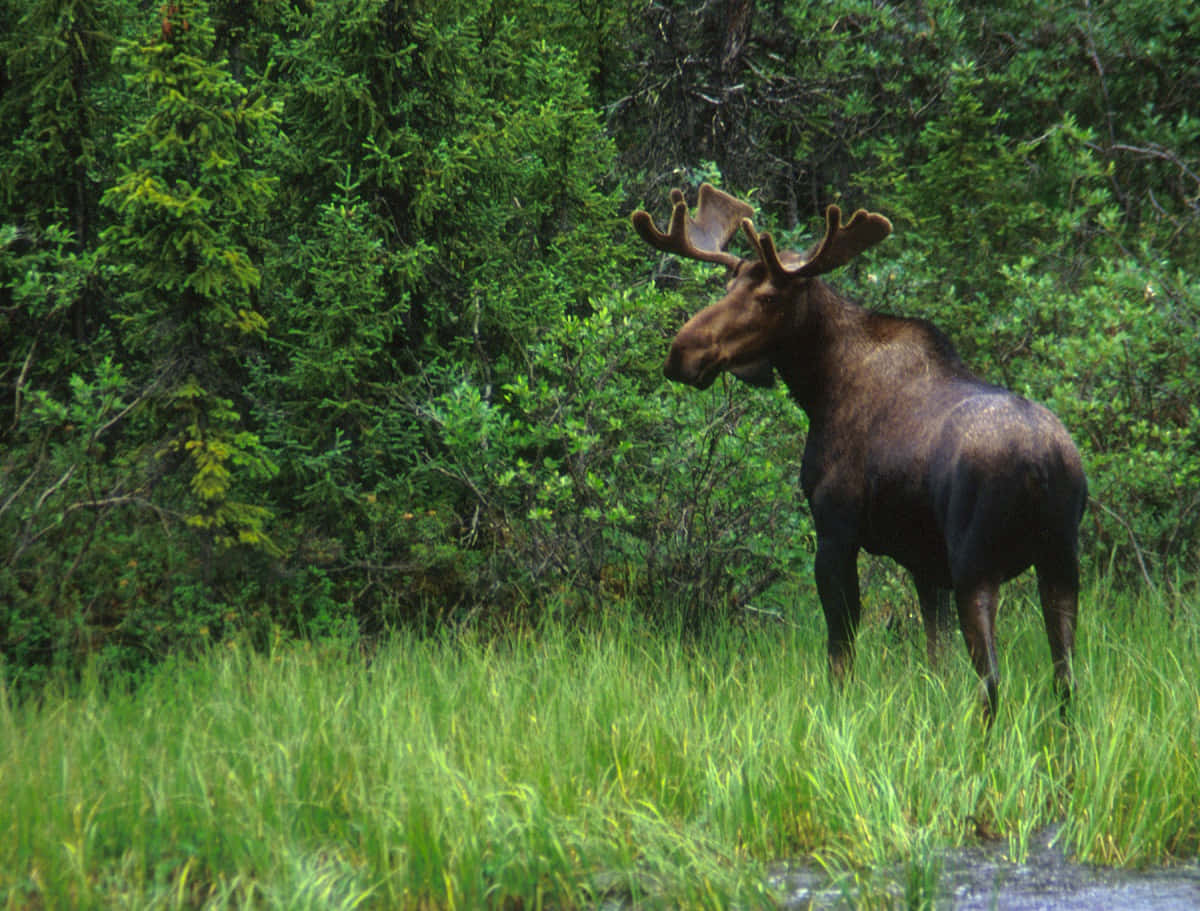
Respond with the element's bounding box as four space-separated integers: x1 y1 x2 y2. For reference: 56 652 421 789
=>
417 290 809 622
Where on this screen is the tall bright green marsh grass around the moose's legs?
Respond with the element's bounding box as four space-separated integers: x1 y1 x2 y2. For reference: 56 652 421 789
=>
0 580 1200 909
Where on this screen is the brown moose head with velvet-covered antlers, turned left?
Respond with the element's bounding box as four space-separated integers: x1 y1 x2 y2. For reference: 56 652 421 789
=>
632 184 892 389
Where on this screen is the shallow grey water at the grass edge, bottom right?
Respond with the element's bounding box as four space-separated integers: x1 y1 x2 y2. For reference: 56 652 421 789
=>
770 829 1200 911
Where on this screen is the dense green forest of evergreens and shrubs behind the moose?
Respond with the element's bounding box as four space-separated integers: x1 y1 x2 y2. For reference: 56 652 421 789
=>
0 0 1200 683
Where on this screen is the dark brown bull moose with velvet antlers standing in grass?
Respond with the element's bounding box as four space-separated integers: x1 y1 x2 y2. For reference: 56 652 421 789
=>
632 184 1087 725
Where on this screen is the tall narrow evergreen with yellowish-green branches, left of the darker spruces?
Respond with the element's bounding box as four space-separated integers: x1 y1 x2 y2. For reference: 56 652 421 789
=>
102 0 278 559
